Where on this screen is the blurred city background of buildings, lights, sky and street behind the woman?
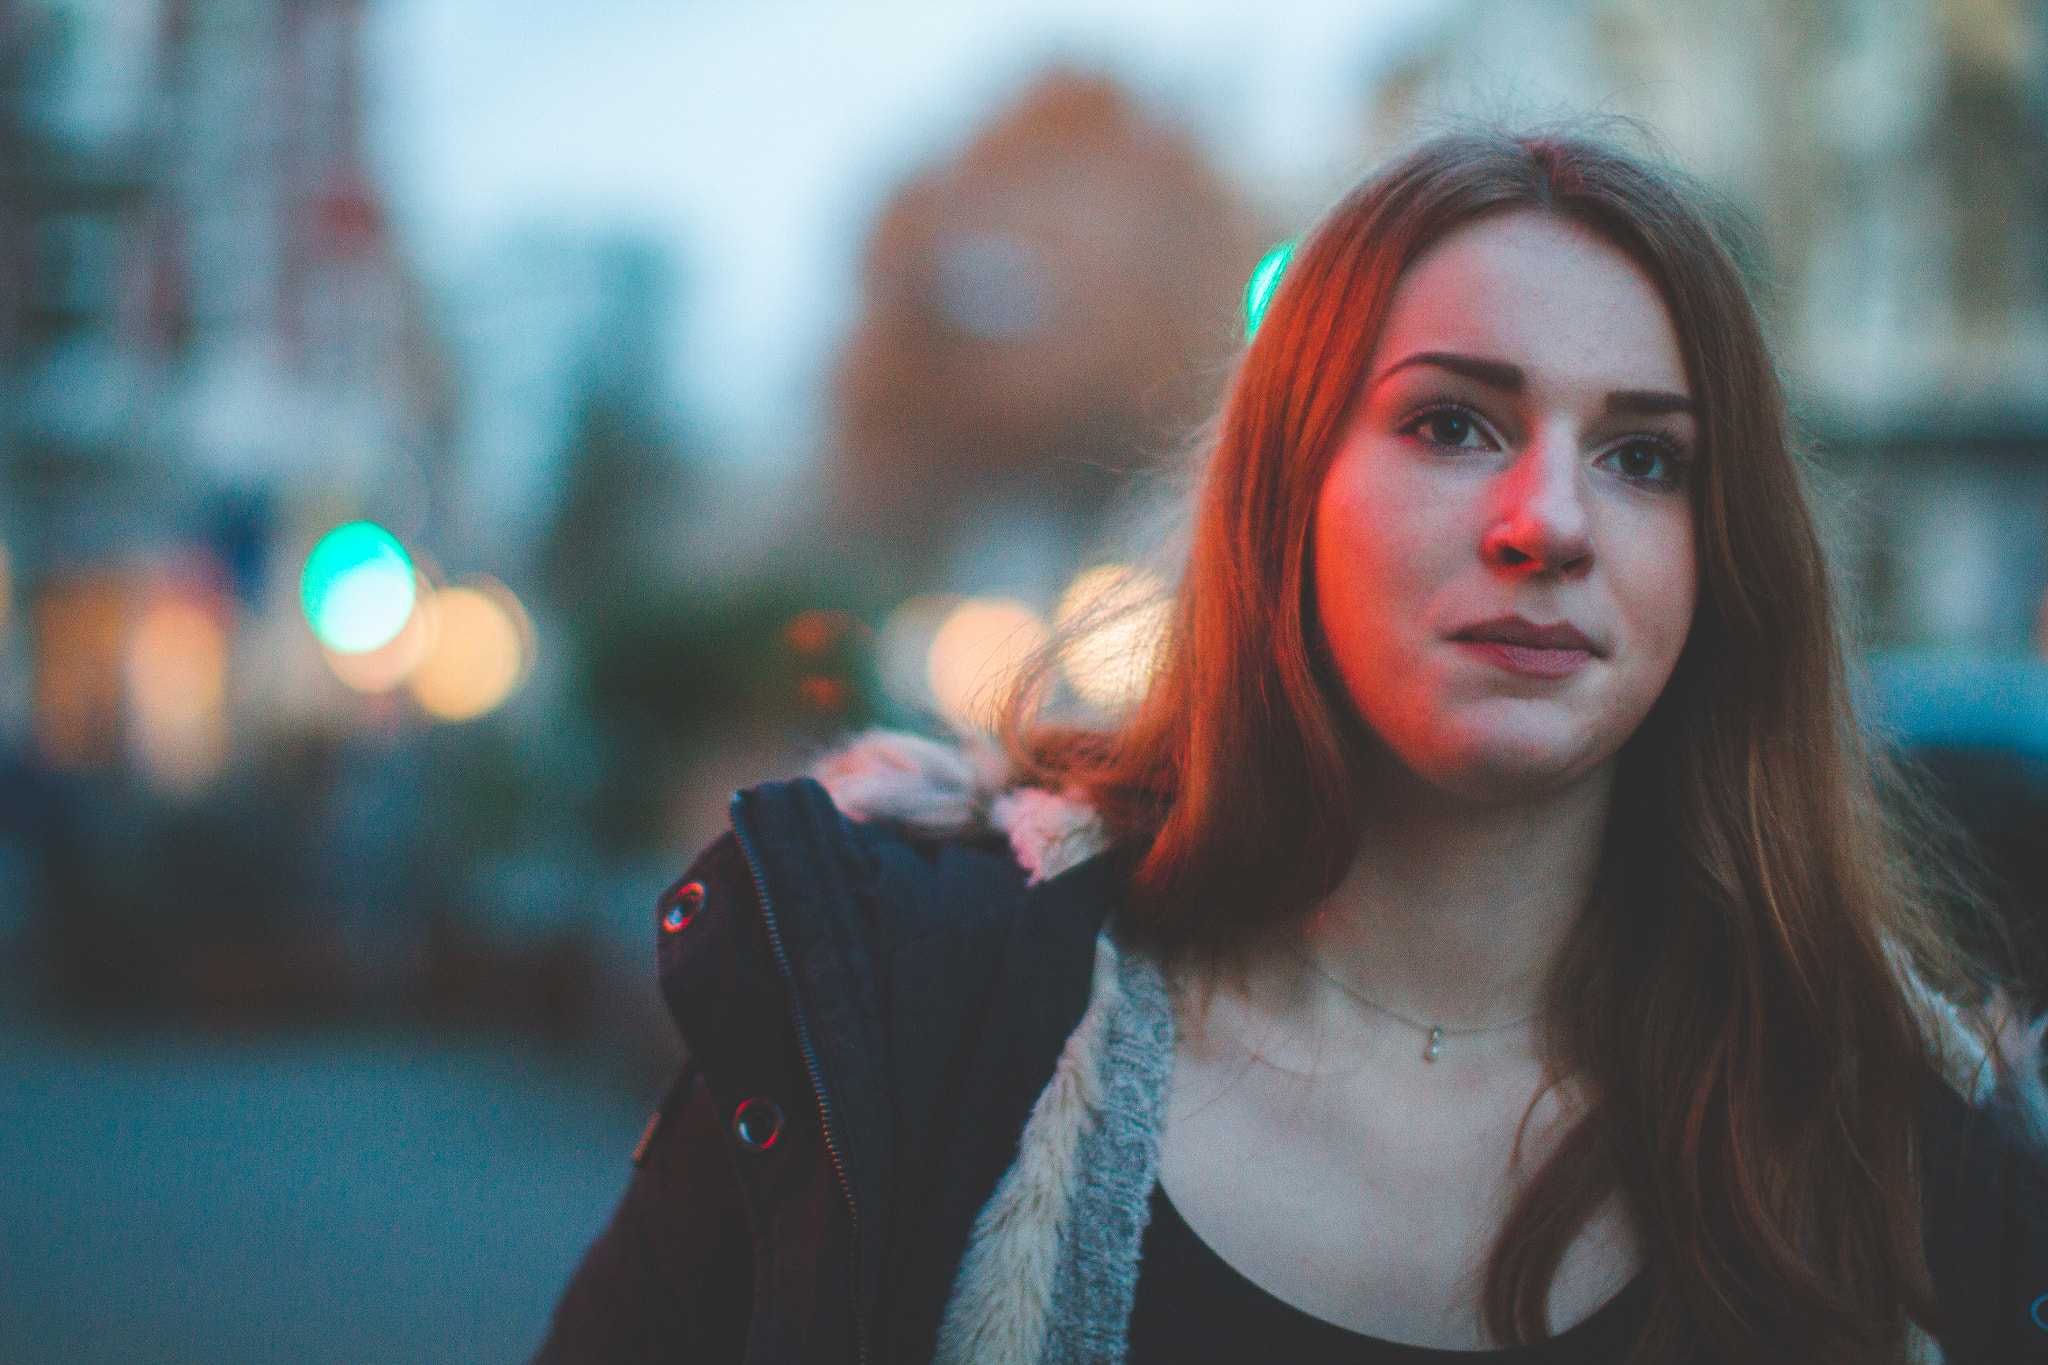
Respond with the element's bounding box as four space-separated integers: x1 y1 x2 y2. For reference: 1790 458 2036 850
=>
0 0 2048 1363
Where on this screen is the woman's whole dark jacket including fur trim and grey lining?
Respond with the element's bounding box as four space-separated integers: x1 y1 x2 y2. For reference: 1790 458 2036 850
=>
539 735 2048 1365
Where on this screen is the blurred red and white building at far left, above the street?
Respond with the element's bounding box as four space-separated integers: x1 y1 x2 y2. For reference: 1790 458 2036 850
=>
0 0 453 786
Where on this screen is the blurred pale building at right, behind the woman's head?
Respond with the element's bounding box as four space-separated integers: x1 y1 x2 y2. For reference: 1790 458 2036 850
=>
1374 0 2048 651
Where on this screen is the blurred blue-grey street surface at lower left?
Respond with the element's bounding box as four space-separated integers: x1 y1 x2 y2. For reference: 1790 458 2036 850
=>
0 1031 657 1365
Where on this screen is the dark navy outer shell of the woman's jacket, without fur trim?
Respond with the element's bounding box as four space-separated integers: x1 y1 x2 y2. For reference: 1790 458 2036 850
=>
537 780 2048 1365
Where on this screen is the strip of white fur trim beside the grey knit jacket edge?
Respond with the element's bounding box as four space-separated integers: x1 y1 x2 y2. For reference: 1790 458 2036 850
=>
934 935 1122 1365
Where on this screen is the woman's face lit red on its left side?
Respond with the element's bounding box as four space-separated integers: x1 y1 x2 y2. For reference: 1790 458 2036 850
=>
1313 213 1696 804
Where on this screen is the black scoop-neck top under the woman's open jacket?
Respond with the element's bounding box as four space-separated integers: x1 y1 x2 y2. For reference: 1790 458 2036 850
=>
1128 1185 1649 1365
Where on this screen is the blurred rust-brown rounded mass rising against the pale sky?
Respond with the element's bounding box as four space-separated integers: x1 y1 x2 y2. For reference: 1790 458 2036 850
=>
836 70 1266 598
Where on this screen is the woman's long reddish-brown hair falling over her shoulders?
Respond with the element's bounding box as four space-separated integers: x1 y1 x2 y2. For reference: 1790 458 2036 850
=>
1008 133 2015 1365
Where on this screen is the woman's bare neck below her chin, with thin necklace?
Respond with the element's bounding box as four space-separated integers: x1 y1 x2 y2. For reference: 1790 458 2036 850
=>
1305 765 1612 1036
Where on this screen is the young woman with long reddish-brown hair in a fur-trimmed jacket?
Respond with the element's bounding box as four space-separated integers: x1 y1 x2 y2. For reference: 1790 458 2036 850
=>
543 135 2048 1365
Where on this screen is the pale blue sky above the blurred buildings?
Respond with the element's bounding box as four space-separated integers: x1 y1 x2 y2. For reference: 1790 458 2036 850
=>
371 0 1444 458
